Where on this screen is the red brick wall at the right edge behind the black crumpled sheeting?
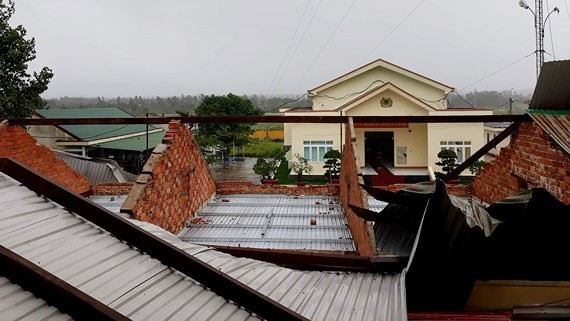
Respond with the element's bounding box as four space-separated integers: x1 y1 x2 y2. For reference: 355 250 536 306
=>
473 123 570 204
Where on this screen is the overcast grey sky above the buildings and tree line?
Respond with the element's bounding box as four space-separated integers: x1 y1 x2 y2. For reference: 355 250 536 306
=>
12 0 570 98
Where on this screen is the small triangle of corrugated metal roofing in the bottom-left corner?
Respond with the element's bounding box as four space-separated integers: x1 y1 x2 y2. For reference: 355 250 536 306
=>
0 276 72 321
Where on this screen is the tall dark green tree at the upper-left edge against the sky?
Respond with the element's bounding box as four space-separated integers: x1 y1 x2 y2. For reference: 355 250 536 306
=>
0 0 53 119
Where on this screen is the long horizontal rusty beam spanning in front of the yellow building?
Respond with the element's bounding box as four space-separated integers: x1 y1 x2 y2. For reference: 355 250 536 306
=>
8 115 530 126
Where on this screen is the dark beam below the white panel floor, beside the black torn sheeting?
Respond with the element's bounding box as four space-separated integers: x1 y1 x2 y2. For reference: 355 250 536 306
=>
212 245 408 273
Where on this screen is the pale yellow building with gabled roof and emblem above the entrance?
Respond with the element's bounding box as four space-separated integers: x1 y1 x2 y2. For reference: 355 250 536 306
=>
285 59 492 175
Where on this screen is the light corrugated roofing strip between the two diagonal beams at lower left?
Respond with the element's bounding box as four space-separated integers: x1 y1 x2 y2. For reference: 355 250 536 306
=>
0 173 258 320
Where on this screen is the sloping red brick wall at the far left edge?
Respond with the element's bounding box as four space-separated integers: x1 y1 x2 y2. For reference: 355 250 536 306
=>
0 121 91 194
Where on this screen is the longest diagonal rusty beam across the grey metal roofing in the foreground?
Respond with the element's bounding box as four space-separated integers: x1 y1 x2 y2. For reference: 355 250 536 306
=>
0 158 308 320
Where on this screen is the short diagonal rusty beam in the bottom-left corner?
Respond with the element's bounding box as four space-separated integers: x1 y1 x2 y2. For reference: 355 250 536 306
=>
0 245 130 320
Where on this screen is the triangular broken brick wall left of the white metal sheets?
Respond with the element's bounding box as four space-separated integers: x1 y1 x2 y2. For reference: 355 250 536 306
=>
121 121 216 233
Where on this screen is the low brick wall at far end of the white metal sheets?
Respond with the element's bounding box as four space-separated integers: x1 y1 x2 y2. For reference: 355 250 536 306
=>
216 182 339 196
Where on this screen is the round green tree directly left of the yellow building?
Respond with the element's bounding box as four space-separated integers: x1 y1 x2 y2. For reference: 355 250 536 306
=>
195 94 263 156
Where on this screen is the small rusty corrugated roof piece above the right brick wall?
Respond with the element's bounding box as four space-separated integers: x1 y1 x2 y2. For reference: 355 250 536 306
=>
530 110 570 154
